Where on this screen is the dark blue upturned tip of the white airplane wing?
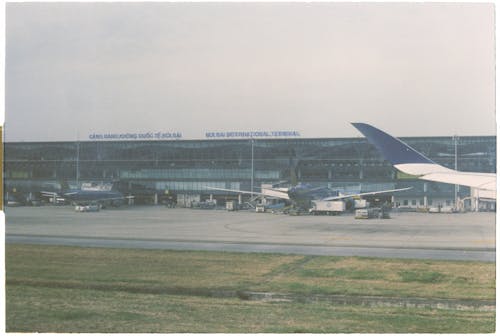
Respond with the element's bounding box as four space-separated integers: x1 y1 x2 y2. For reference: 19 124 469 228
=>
352 123 435 165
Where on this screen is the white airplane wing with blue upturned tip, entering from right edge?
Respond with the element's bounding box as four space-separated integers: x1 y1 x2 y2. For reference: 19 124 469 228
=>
352 123 497 200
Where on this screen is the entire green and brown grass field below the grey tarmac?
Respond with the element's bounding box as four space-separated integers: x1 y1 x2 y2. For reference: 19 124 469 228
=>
6 244 495 333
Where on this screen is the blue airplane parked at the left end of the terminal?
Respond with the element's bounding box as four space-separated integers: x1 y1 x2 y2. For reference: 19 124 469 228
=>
42 183 134 206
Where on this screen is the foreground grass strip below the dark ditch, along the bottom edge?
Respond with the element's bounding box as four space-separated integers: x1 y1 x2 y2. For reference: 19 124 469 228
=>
7 286 495 333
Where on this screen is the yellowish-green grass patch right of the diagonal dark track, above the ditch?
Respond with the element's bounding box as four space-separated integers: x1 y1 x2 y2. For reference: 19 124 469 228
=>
258 253 495 299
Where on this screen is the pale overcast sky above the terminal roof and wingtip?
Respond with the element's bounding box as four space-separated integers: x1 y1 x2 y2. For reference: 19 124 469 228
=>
5 2 497 141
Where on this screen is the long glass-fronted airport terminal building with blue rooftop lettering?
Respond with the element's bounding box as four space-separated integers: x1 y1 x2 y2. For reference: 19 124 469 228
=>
4 136 496 209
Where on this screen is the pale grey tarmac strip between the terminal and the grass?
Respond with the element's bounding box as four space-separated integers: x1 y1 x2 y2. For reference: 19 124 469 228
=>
5 206 496 262
